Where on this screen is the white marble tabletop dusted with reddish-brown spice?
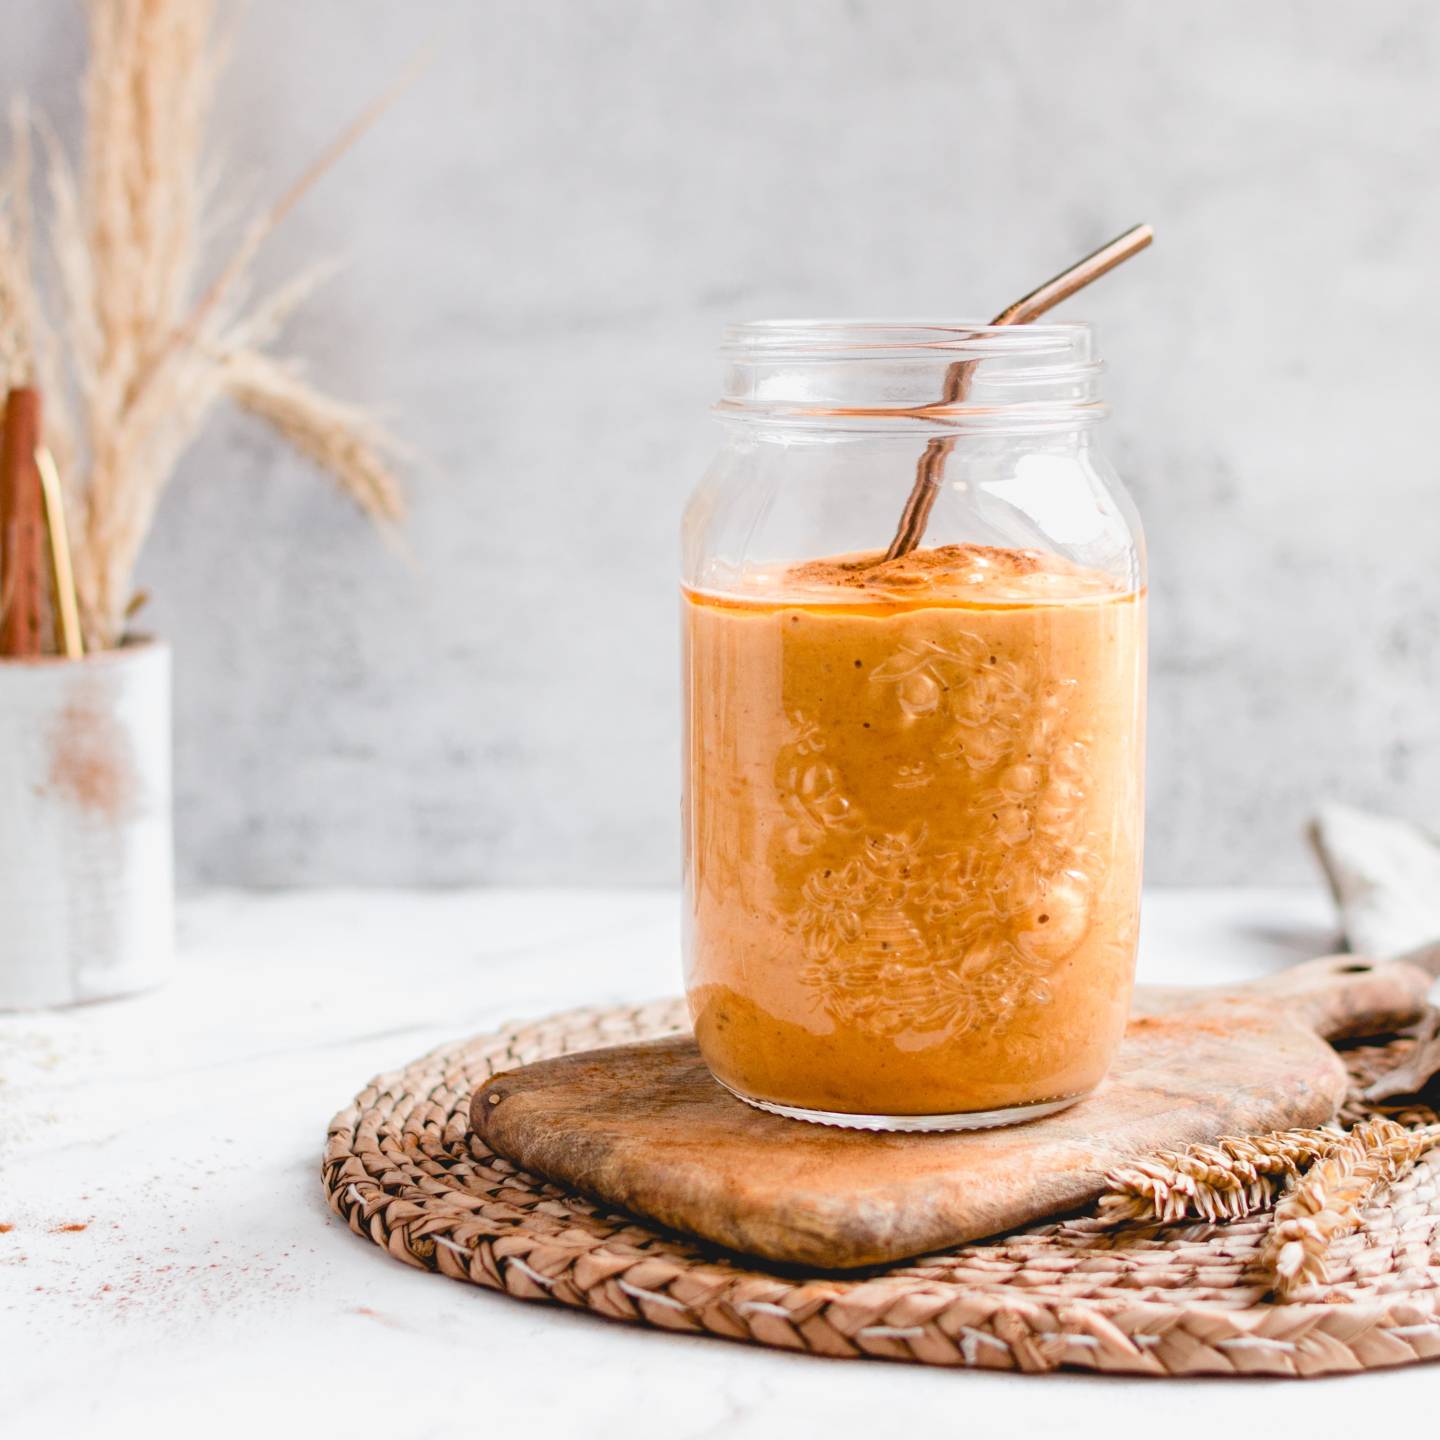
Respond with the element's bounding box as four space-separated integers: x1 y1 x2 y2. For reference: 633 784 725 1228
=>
0 890 1440 1440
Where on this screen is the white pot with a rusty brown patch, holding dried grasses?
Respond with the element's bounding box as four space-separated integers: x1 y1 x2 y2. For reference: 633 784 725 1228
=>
0 641 174 1009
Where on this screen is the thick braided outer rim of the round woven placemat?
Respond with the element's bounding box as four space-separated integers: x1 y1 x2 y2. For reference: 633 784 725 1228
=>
323 1001 1440 1377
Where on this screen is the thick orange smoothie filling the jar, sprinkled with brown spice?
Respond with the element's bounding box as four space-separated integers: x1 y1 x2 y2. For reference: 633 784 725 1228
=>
684 546 1145 1117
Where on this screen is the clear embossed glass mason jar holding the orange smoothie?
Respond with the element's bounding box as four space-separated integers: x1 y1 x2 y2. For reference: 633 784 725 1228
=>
683 321 1145 1130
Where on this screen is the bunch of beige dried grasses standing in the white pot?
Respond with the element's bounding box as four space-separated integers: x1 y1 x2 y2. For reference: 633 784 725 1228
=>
0 0 403 648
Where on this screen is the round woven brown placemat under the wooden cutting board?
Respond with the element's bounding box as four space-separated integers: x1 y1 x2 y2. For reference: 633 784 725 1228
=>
324 999 1440 1375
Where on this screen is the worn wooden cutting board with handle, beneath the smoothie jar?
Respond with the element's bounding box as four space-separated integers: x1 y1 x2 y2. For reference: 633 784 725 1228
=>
471 955 1433 1269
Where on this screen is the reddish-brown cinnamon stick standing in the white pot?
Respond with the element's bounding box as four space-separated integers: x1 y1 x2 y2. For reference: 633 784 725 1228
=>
0 386 48 658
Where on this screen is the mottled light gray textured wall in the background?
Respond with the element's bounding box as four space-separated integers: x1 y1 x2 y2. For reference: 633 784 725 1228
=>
0 0 1440 884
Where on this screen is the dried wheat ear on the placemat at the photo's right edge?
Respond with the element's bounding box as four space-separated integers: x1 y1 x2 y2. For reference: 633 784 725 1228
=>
1260 1119 1440 1300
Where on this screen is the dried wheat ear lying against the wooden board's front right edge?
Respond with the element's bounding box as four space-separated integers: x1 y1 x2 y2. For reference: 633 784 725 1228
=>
1100 1129 1345 1225
